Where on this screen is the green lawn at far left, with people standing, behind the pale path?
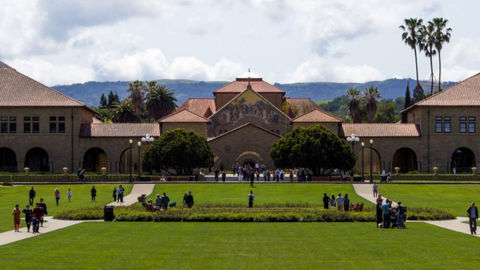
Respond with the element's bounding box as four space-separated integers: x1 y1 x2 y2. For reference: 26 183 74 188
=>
0 184 132 232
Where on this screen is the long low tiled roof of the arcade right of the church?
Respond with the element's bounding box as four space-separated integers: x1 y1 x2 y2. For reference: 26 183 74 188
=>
342 123 420 137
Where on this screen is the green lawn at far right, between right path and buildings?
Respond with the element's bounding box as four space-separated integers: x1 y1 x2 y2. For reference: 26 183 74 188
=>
378 184 480 216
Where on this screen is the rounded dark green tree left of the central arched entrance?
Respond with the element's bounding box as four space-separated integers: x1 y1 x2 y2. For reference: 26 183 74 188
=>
142 129 214 175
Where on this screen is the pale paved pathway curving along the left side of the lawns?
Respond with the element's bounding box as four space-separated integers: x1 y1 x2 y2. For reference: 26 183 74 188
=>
0 184 155 246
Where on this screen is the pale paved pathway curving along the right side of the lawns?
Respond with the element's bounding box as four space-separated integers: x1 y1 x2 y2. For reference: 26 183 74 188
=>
353 184 480 237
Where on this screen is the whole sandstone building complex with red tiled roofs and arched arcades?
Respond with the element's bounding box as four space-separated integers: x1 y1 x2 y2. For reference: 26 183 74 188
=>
0 62 480 172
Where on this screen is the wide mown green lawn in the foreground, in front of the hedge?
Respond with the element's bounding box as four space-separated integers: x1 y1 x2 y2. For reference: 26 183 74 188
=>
0 222 480 270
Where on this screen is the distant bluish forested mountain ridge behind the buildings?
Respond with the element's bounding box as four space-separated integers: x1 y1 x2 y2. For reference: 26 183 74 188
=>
52 79 456 106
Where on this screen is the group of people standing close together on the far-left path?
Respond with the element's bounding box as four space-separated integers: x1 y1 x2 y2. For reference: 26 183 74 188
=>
12 197 48 233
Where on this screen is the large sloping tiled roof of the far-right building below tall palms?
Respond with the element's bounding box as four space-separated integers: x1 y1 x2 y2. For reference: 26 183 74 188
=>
403 73 480 111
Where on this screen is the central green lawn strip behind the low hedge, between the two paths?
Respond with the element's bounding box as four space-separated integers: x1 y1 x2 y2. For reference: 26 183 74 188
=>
146 184 370 205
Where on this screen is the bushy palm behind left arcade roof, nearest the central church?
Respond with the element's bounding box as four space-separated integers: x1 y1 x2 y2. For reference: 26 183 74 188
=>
146 81 177 119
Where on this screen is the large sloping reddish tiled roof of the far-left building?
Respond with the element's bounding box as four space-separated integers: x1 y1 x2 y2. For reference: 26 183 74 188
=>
0 62 86 107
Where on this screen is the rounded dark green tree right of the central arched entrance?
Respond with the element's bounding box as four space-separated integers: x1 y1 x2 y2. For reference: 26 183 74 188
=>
270 124 355 175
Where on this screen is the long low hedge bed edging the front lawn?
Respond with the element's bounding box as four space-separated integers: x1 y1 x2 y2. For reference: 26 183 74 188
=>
55 205 456 222
